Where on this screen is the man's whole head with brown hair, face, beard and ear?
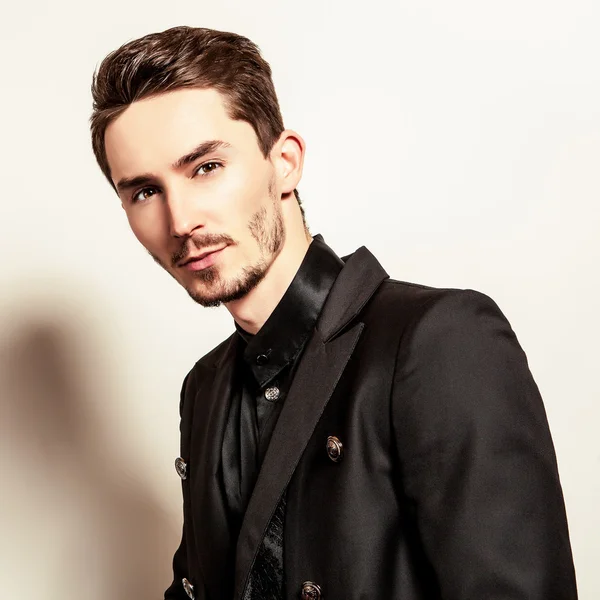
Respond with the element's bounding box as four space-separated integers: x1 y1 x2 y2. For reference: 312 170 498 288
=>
91 27 307 306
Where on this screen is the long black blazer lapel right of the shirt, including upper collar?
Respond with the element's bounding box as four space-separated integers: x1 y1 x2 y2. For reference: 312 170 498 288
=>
234 247 387 599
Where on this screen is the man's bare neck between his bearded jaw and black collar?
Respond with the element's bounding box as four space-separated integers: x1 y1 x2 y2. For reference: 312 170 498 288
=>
226 234 312 334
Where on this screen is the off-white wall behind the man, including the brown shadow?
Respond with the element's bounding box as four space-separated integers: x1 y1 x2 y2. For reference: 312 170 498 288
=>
0 0 600 600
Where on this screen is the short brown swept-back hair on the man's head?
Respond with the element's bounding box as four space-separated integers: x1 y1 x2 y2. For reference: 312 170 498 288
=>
90 27 304 219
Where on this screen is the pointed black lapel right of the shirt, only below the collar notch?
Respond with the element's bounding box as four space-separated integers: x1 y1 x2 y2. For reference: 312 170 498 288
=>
234 323 364 598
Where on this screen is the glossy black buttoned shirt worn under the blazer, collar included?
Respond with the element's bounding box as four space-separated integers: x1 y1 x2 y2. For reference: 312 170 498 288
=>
222 235 344 540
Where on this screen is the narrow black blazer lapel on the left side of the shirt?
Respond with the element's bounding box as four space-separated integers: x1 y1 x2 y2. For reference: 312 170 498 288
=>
190 336 237 599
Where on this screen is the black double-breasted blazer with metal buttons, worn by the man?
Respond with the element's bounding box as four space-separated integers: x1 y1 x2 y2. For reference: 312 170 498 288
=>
165 247 577 600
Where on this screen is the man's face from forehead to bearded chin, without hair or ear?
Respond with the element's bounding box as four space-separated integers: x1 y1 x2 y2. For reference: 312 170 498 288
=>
105 89 285 306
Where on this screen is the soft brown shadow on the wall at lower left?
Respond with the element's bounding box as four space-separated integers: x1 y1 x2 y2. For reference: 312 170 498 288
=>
0 300 174 600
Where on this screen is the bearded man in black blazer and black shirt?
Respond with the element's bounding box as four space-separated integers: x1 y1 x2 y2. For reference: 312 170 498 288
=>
92 27 577 600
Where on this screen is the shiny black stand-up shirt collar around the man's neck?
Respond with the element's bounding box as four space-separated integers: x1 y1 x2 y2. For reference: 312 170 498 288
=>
235 235 344 387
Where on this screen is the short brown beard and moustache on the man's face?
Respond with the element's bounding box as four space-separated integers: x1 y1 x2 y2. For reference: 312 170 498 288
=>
151 180 285 307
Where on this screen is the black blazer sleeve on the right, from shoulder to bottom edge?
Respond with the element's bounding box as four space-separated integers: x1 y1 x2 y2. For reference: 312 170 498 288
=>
392 291 577 600
